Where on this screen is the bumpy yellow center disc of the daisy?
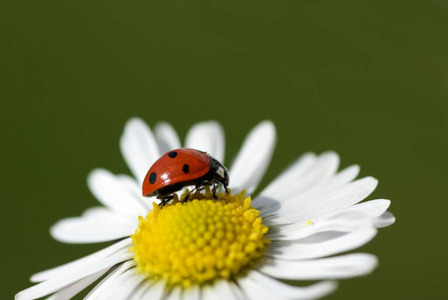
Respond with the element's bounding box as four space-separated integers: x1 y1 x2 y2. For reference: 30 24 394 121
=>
131 189 269 287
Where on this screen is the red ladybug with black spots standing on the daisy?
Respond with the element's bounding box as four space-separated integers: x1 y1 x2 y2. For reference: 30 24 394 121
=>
142 148 229 207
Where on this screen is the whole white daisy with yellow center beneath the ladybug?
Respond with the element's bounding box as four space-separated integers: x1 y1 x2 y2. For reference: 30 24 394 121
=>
16 118 395 300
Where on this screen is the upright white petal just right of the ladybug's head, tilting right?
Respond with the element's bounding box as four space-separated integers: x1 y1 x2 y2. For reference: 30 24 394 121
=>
230 121 276 194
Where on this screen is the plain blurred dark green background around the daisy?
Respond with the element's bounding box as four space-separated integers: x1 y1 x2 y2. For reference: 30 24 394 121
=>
0 0 448 299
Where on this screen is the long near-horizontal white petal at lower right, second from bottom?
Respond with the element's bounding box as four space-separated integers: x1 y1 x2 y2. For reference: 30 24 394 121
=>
258 253 378 280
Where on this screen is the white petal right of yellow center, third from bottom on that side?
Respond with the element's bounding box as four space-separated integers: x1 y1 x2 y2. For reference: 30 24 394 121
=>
265 227 377 260
